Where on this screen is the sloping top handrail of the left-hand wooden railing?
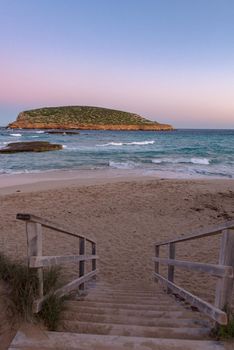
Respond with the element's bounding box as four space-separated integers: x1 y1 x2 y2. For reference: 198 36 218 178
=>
16 213 95 243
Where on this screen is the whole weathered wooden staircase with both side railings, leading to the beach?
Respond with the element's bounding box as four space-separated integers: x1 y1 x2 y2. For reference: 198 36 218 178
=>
9 214 234 350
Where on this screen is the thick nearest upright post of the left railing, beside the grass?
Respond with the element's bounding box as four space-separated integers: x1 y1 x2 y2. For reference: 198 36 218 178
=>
26 221 43 298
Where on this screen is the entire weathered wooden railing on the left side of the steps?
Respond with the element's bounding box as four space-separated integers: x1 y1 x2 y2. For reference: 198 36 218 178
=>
16 214 98 313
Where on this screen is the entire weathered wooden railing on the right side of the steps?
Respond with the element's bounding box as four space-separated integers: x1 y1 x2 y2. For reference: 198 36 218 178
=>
153 221 234 325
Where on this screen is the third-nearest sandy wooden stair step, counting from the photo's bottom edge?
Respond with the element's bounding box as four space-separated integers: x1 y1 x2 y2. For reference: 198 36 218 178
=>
63 303 204 318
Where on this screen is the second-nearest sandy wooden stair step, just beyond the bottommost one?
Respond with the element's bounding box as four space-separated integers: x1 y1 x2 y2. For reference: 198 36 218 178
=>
58 321 210 339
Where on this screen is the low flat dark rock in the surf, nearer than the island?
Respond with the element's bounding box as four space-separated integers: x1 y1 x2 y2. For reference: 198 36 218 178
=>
0 141 63 154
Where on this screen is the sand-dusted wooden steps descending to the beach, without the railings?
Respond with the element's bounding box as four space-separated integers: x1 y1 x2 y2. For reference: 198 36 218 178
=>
9 282 224 350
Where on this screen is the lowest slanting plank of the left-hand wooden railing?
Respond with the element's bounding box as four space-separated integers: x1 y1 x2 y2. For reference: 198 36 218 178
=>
33 270 98 313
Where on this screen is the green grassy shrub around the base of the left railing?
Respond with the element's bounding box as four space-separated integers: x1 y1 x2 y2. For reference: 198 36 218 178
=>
0 253 65 330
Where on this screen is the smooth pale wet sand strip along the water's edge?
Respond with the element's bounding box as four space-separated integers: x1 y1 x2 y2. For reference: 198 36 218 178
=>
0 169 234 195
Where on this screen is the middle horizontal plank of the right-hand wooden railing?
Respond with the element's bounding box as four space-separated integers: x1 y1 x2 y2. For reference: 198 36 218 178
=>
153 258 234 278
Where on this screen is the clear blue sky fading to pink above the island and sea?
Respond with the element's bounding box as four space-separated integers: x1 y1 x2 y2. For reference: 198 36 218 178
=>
0 0 234 128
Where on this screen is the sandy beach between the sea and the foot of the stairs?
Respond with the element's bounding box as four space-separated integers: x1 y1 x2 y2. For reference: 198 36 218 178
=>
0 173 234 348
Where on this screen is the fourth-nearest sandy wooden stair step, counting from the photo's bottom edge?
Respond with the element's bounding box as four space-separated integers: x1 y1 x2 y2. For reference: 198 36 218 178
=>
65 300 184 311
